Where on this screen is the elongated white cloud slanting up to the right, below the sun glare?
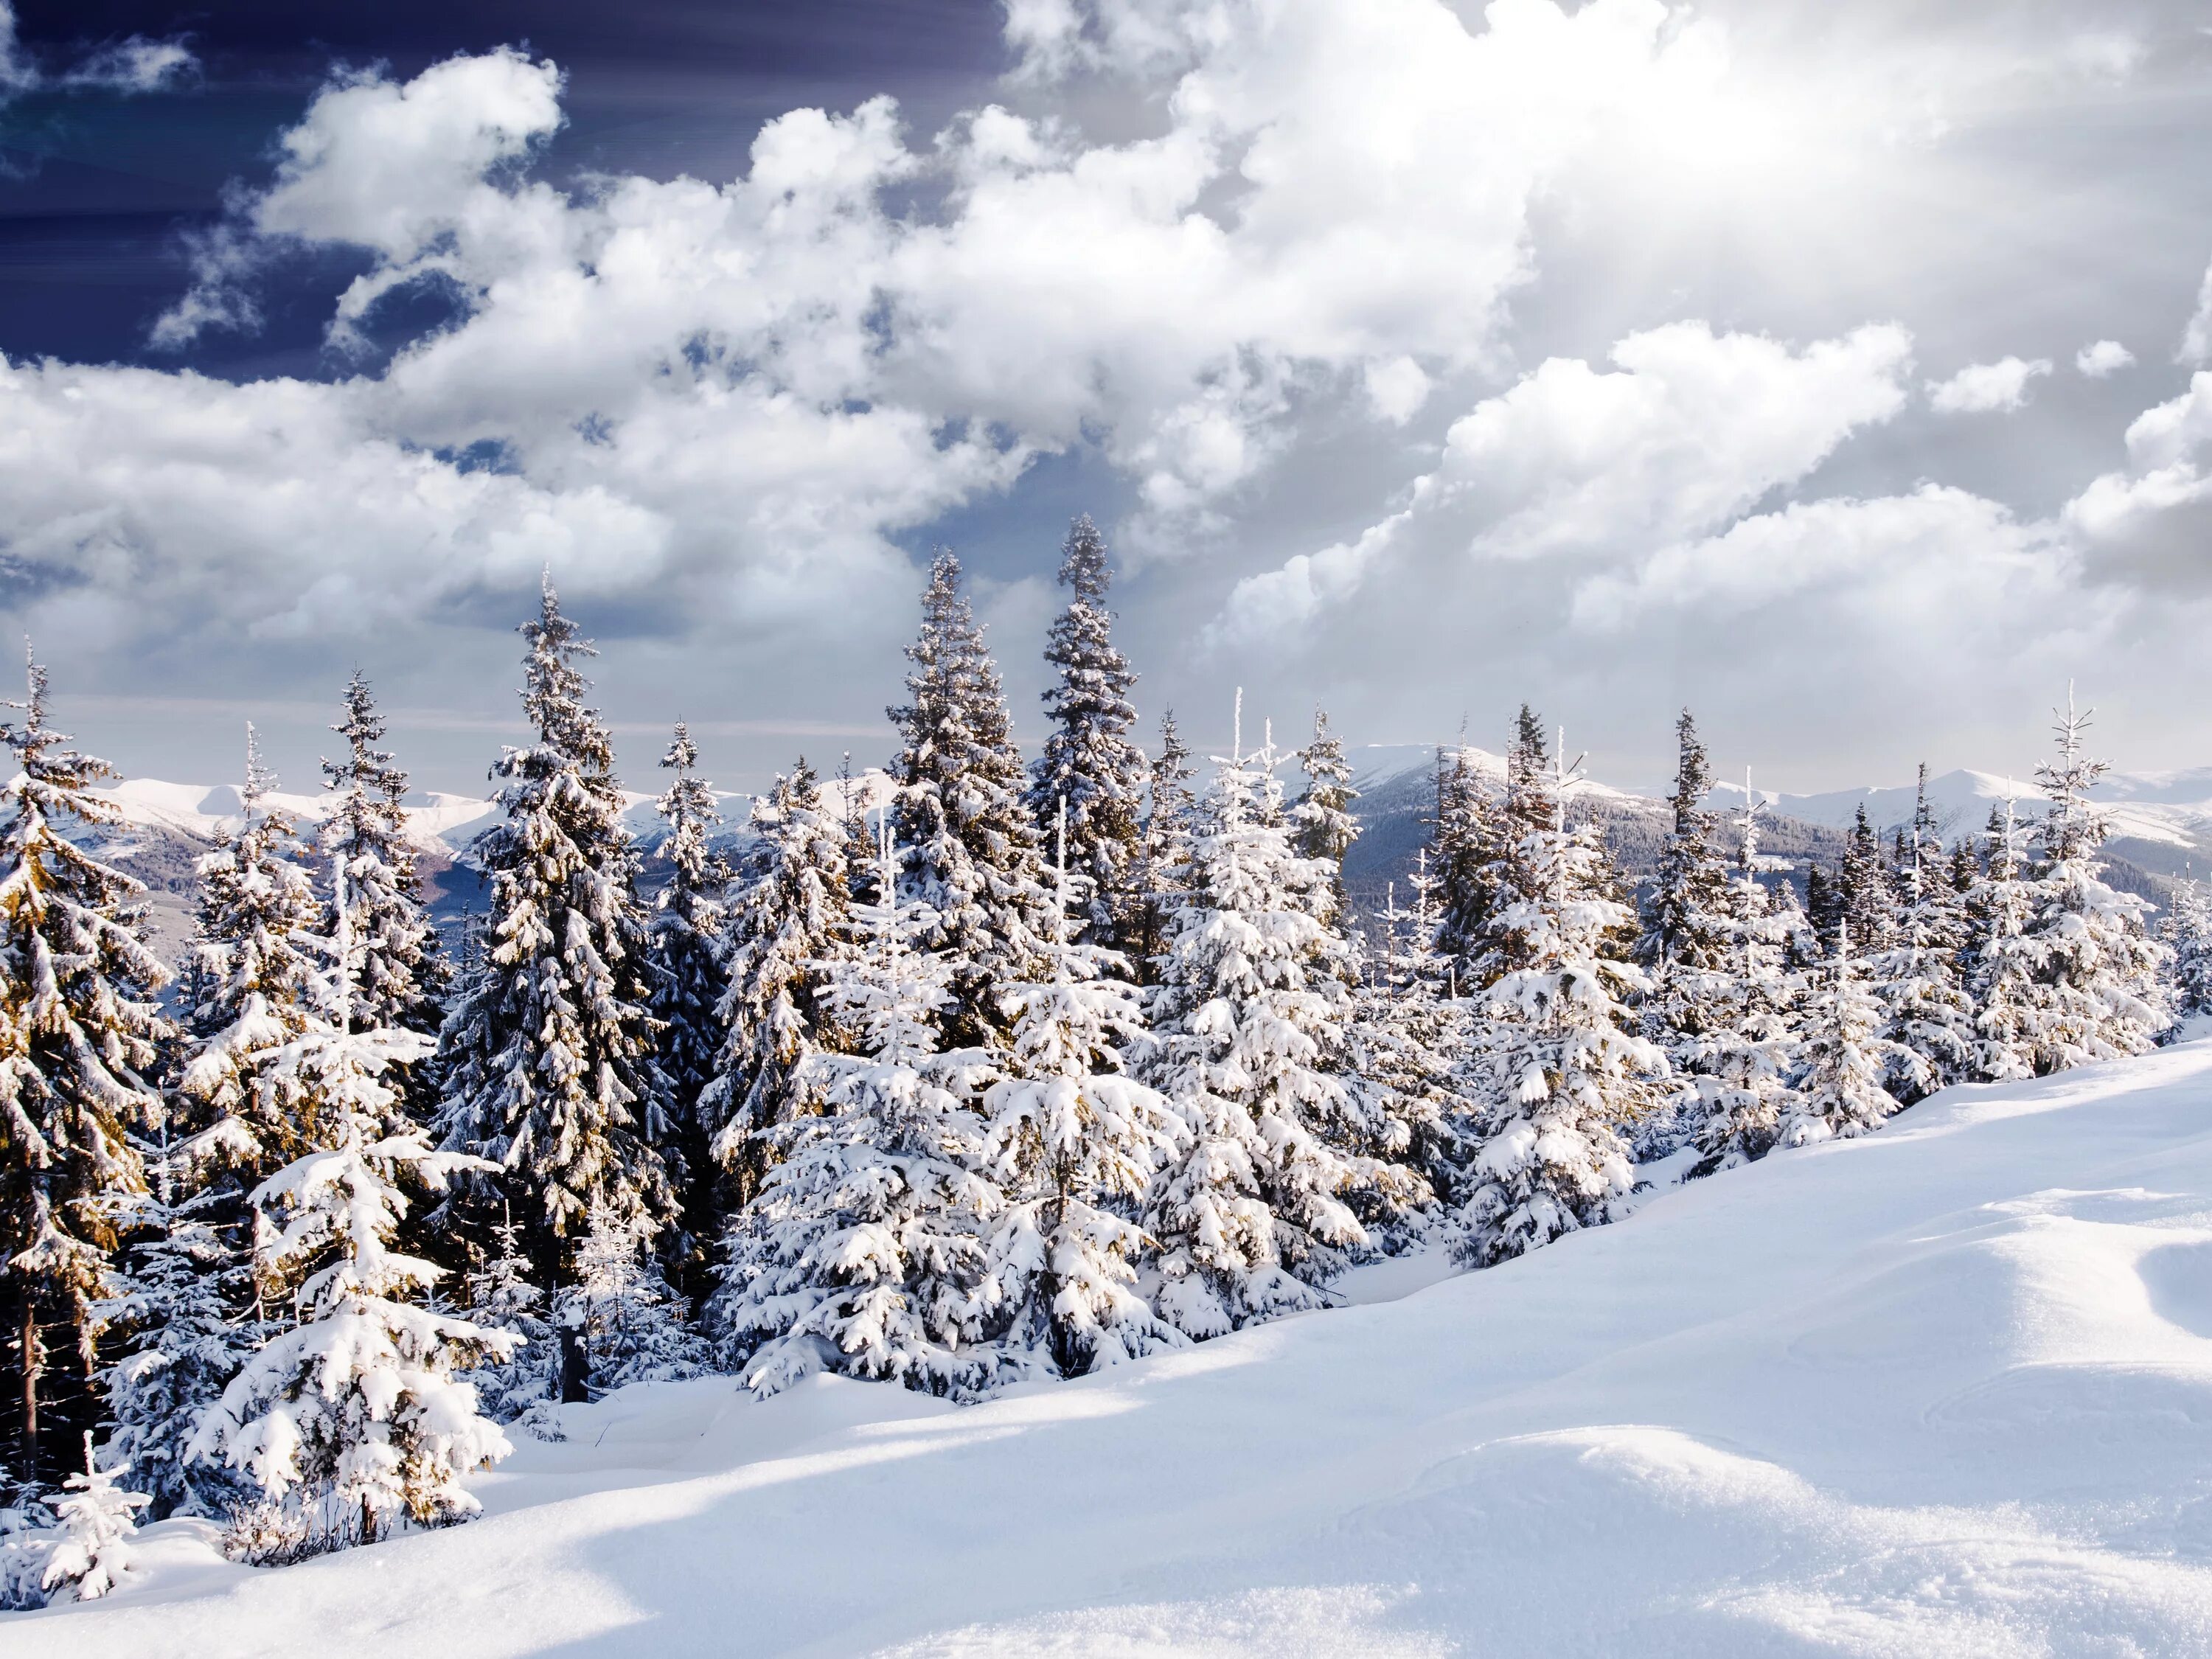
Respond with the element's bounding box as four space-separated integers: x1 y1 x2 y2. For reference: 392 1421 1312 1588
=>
1214 323 1911 644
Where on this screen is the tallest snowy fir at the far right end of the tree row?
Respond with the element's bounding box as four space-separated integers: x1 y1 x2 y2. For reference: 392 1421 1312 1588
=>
2028 688 2172 1073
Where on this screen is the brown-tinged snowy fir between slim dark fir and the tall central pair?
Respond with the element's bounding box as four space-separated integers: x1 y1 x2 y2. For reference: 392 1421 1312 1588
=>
701 761 852 1208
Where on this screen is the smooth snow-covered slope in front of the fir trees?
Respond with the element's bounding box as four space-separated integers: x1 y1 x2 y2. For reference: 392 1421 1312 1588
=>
34 1040 2212 1659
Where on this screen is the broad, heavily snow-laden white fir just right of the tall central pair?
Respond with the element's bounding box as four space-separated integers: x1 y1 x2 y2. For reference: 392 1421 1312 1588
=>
1144 699 1418 1338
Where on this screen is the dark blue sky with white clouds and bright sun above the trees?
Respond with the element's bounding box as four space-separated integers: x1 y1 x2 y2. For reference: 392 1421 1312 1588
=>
0 0 2212 794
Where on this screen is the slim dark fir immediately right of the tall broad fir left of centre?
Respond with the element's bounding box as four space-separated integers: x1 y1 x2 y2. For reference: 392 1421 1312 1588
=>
648 721 730 1267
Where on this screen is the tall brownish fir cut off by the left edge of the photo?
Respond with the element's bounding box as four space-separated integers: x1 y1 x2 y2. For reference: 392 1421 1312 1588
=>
0 653 170 1482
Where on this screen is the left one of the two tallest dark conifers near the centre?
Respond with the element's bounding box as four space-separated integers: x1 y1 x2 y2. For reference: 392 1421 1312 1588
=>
889 553 1048 1046
